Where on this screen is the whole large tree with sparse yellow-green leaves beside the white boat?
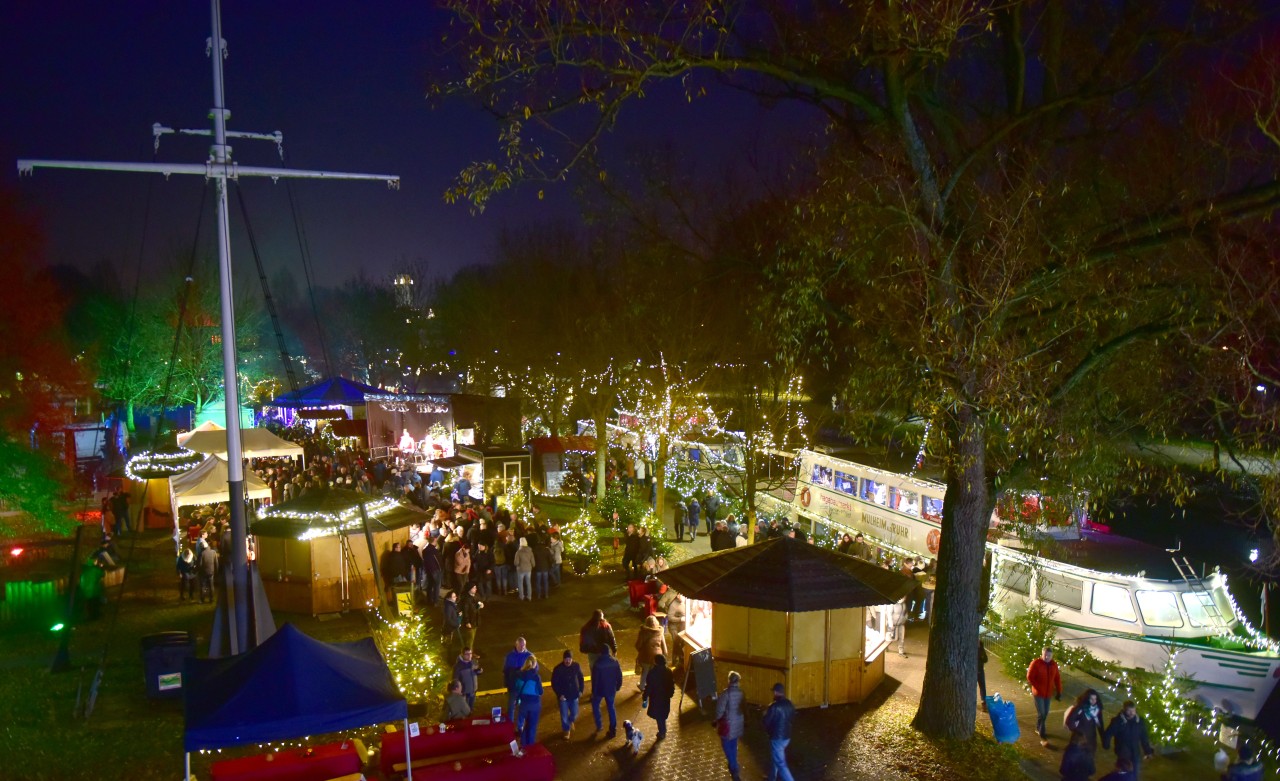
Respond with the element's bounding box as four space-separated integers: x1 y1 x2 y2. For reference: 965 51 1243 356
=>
438 0 1280 739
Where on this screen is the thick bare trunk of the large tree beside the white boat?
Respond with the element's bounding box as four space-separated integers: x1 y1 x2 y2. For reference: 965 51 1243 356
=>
911 406 992 740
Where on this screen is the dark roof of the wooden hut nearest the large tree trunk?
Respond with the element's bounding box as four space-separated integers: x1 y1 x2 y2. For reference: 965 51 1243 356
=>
659 536 915 613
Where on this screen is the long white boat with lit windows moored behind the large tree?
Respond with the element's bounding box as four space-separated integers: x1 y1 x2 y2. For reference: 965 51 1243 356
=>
791 451 1280 718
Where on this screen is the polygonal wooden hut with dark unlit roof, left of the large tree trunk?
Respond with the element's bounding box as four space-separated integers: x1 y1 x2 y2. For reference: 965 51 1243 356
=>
662 538 915 708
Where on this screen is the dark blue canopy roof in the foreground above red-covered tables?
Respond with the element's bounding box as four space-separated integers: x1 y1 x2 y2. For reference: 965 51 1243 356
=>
183 624 408 752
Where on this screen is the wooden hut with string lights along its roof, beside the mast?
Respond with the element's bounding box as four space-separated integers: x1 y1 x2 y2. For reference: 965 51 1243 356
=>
250 488 430 616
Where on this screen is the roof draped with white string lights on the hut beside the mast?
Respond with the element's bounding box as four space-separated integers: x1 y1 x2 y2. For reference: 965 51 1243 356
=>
250 488 430 539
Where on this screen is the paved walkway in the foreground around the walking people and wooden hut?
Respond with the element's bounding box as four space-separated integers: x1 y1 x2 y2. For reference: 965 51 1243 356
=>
450 499 1215 781
